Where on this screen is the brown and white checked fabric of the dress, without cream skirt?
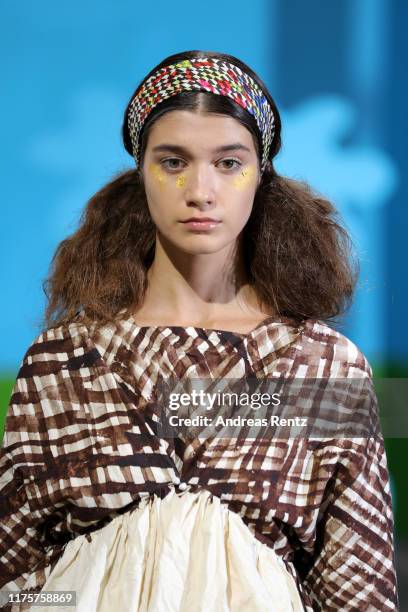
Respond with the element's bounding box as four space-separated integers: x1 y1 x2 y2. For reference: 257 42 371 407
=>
0 317 397 612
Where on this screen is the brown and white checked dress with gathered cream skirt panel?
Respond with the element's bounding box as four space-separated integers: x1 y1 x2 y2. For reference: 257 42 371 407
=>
0 317 397 611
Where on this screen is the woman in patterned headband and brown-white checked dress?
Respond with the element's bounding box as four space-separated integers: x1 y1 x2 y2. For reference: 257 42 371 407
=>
0 51 397 611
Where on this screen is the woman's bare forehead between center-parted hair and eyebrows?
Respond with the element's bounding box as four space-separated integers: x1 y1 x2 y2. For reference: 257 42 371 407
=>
147 111 255 151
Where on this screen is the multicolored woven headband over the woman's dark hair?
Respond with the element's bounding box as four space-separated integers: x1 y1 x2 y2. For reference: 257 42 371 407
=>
128 58 275 172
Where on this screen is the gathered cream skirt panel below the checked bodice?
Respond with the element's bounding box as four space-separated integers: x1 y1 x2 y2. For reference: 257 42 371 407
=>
35 489 304 612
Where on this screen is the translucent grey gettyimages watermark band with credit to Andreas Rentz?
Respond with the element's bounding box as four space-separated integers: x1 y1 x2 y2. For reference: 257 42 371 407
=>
150 376 408 440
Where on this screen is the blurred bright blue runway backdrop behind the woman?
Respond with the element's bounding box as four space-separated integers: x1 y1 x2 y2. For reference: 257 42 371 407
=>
0 0 408 536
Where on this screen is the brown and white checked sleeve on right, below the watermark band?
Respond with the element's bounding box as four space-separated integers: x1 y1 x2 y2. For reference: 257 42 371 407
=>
303 370 398 612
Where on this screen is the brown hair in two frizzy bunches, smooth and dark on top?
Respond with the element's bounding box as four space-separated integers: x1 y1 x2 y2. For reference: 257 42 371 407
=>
44 51 358 327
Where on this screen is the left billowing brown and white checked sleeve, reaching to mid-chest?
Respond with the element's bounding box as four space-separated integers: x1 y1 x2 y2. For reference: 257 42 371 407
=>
0 316 181 590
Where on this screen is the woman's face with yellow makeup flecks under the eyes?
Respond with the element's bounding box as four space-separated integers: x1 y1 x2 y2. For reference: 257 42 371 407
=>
142 111 260 254
